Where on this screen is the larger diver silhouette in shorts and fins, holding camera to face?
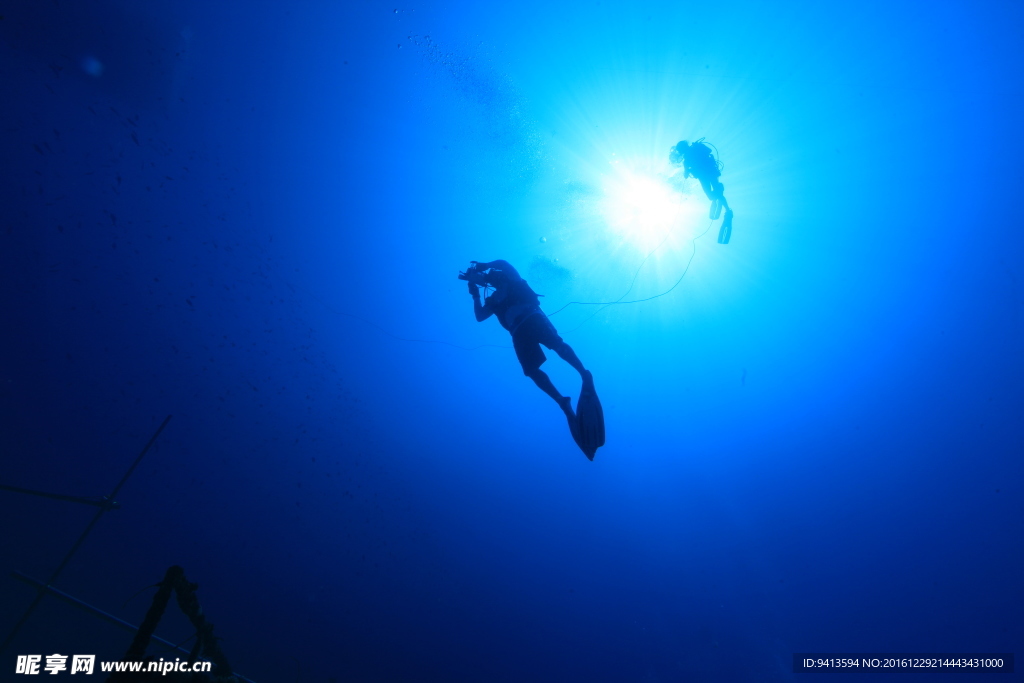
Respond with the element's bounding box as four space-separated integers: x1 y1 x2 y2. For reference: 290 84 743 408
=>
459 260 604 460
